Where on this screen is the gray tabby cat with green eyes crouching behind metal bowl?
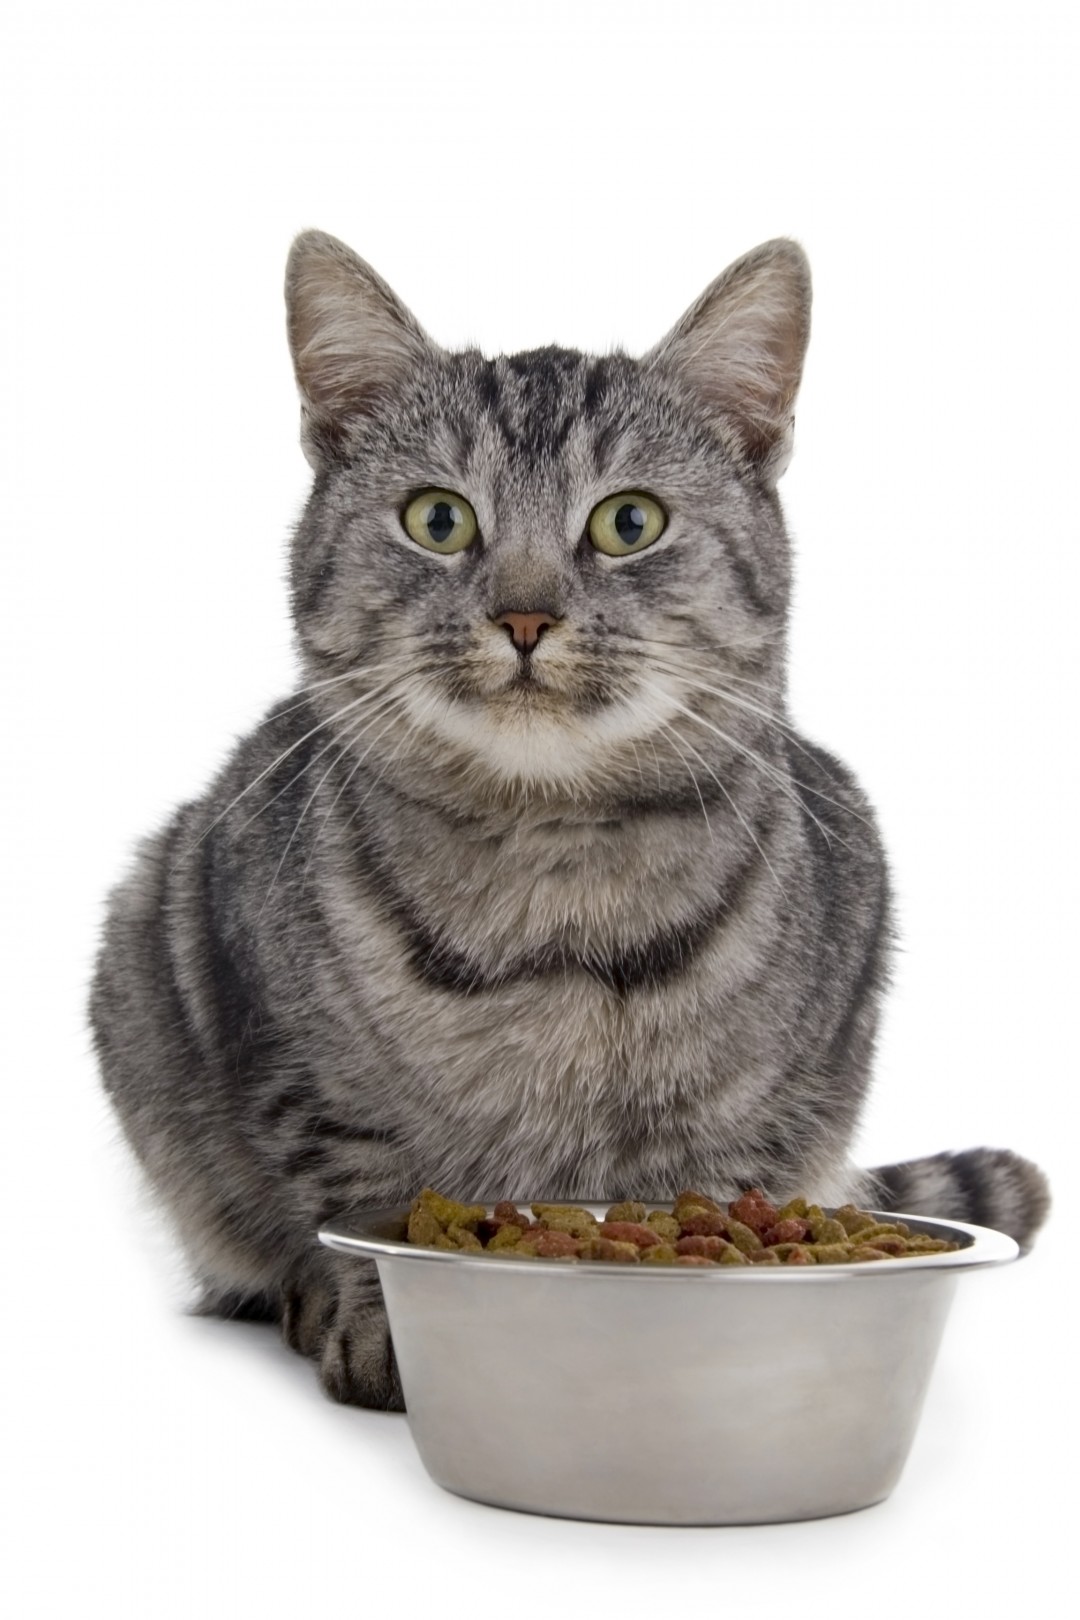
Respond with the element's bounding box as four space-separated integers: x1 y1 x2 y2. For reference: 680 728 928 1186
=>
92 232 1048 1406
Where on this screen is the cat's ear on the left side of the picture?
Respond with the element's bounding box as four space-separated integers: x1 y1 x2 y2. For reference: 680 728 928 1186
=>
285 230 439 467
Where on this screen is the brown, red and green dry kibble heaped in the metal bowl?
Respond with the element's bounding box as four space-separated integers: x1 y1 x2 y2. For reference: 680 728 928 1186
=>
408 1187 960 1265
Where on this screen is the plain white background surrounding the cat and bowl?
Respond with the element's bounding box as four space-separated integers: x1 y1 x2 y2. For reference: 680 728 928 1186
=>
0 0 1080 1620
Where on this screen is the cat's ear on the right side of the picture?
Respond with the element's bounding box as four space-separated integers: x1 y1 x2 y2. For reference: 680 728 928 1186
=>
644 237 810 480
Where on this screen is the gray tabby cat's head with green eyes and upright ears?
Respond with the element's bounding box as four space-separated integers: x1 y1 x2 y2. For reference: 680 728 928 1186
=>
287 232 810 797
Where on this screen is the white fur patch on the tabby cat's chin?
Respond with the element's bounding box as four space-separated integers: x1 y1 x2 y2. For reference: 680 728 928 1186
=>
396 684 678 789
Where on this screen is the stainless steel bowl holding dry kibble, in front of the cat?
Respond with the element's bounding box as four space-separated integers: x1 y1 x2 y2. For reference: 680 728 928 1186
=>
319 1205 1018 1524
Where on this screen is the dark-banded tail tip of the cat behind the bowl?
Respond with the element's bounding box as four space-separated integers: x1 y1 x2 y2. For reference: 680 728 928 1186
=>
868 1147 1051 1249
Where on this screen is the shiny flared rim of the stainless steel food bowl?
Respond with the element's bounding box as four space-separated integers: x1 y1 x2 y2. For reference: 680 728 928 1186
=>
319 1199 1020 1286
